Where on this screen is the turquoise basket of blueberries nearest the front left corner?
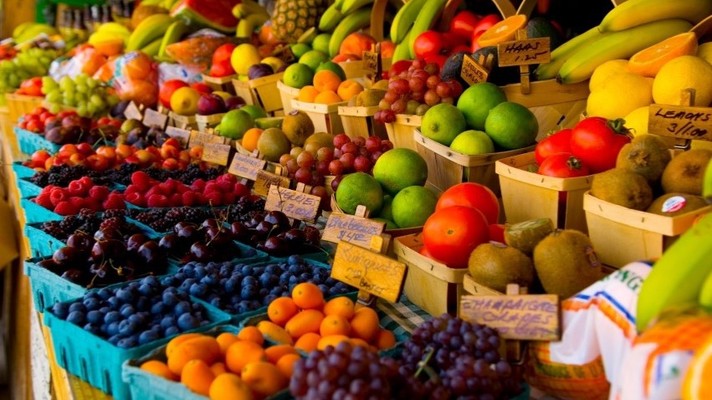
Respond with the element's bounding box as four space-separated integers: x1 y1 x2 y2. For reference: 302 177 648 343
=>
44 297 229 400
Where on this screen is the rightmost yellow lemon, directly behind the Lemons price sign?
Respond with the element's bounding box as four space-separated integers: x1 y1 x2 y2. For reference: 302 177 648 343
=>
652 56 712 107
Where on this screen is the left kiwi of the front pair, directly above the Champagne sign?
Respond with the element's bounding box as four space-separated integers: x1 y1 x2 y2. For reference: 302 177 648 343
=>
467 242 534 293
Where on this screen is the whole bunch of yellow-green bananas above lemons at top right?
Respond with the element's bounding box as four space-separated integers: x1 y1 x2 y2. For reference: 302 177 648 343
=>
536 0 712 83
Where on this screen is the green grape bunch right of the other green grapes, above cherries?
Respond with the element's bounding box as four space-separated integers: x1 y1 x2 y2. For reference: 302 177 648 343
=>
42 74 119 117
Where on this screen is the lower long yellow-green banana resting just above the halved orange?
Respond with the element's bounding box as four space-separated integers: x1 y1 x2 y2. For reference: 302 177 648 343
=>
556 19 692 83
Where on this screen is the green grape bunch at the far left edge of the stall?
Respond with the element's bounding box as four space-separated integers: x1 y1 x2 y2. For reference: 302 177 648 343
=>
0 47 59 93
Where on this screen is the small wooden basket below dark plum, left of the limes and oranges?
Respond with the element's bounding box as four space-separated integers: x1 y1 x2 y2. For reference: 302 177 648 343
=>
232 72 286 117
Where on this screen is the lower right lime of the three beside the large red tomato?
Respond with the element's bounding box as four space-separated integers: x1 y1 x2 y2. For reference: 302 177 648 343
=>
393 186 438 228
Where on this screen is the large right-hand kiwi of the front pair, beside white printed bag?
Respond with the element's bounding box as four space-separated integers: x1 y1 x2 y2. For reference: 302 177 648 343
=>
533 229 603 299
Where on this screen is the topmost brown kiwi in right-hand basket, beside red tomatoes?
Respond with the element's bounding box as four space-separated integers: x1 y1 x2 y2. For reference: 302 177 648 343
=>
616 134 672 183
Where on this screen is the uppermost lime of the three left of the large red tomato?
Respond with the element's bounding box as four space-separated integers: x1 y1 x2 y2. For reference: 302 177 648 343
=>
373 148 428 195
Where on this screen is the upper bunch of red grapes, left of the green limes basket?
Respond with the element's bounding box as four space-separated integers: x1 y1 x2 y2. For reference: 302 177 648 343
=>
373 60 463 123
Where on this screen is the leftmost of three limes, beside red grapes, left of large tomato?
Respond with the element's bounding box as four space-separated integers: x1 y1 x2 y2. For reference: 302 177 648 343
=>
336 172 383 214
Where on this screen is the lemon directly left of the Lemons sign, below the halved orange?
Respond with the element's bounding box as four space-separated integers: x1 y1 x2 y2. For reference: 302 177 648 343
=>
586 73 653 119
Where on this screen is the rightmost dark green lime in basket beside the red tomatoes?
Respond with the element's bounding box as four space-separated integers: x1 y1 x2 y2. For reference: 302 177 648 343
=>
485 101 539 150
